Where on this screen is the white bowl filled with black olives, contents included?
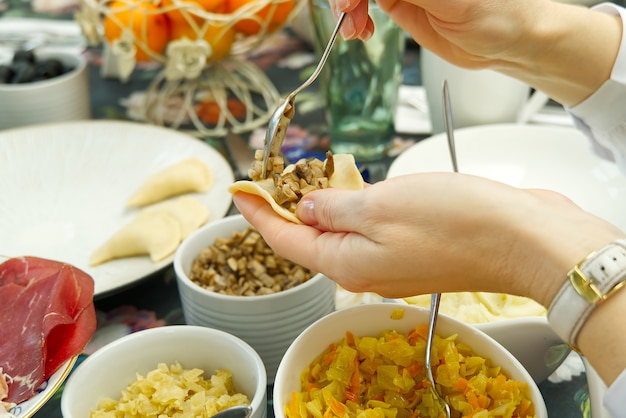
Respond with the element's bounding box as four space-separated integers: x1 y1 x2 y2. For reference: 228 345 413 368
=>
0 50 91 129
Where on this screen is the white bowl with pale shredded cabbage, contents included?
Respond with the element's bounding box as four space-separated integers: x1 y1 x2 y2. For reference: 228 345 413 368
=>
61 325 267 418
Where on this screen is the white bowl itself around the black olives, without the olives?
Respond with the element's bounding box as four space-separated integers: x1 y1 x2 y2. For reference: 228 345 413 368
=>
0 52 91 129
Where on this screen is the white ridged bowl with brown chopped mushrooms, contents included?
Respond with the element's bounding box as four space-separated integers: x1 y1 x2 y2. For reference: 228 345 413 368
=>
174 215 336 383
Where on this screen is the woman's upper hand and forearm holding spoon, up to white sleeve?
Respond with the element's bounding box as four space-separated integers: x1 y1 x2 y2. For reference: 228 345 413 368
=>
334 0 622 106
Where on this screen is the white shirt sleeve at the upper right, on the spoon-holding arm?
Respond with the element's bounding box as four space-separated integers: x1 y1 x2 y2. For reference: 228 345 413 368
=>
567 3 626 173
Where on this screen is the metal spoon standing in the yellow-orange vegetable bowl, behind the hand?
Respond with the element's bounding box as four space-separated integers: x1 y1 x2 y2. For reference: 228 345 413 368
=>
425 80 459 418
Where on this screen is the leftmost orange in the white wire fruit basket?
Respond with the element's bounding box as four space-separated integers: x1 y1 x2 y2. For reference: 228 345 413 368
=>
103 1 170 62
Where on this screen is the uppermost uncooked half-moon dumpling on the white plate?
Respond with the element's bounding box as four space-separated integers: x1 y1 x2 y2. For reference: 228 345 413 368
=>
126 158 213 207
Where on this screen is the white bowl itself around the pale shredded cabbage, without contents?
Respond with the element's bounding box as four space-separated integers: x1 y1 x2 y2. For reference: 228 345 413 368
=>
61 325 267 418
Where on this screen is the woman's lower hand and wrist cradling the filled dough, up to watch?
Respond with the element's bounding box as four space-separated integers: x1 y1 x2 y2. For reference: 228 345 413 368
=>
234 173 622 304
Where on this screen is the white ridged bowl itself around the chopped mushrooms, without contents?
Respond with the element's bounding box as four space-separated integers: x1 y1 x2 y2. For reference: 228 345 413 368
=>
174 215 336 383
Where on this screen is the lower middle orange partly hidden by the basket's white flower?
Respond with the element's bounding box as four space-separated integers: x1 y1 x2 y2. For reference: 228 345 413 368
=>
171 21 237 61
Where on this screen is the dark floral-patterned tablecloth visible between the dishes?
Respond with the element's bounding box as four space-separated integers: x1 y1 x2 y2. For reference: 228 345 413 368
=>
0 0 589 418
